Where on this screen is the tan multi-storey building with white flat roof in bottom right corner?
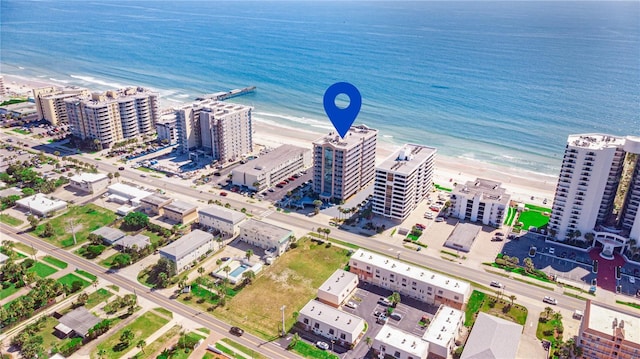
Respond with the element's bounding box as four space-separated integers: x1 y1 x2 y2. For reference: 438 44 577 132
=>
578 300 640 359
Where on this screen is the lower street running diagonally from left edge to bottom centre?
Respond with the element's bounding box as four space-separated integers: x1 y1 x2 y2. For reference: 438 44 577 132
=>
0 223 299 358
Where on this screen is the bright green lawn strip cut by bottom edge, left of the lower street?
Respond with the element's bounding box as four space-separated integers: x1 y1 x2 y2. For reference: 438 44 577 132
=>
91 311 169 359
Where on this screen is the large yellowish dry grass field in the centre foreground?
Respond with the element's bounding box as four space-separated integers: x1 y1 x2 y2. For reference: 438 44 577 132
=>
214 239 349 339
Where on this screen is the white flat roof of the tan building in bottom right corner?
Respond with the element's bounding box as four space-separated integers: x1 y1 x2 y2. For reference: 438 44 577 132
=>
583 301 640 344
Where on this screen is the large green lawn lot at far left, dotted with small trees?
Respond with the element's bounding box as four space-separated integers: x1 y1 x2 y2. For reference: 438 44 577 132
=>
33 204 116 247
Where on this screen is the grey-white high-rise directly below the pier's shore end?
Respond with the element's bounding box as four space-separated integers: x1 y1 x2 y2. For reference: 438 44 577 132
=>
176 100 253 163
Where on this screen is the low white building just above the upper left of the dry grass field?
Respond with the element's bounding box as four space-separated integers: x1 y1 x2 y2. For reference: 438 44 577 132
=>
238 218 293 256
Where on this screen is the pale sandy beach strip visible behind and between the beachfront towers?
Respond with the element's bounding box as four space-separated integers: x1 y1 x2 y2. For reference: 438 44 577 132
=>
0 74 557 207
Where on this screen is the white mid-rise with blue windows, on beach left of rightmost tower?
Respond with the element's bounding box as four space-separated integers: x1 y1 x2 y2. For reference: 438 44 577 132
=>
450 178 511 228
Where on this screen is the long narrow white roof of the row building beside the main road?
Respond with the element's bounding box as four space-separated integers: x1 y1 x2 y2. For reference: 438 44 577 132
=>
351 248 471 295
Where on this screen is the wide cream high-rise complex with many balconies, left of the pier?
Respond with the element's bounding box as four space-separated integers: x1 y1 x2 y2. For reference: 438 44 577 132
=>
64 87 159 148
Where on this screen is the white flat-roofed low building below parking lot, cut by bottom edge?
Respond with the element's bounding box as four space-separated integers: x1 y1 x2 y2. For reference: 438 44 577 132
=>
371 324 429 359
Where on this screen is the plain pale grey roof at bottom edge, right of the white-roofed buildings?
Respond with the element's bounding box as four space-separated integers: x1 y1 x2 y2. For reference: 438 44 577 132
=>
461 312 523 359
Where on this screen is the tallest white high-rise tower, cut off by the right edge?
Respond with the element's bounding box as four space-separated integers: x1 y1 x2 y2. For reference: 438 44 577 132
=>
549 134 640 256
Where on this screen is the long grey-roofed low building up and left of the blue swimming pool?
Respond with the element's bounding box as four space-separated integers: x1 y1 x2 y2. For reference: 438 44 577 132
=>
160 229 215 272
